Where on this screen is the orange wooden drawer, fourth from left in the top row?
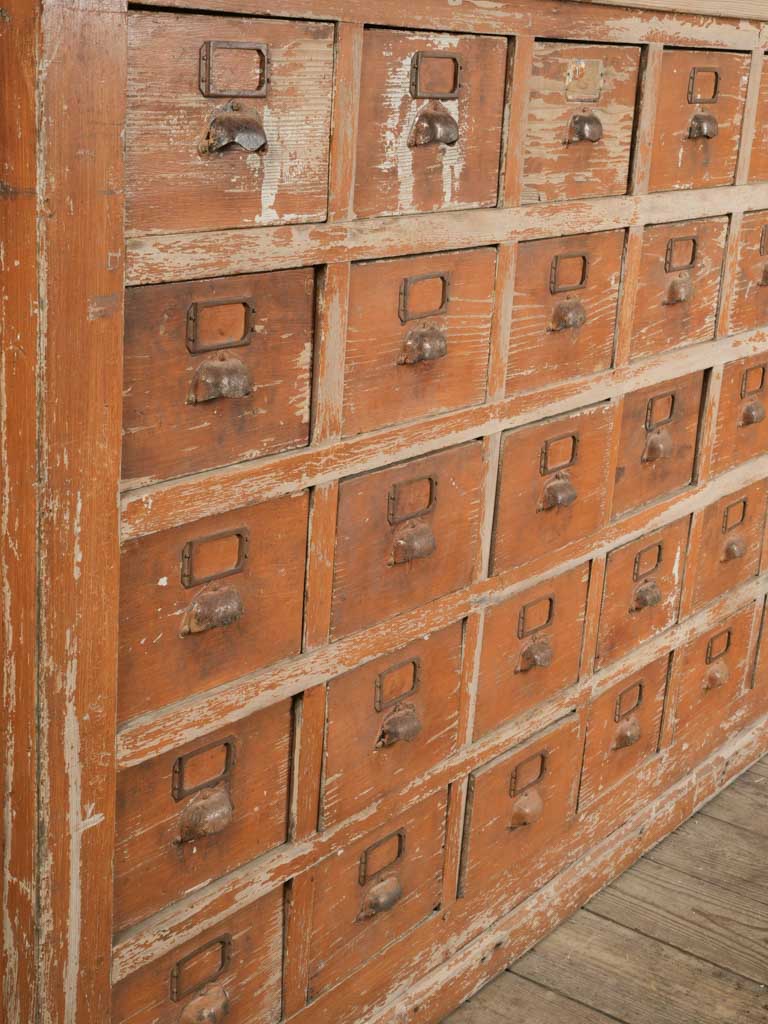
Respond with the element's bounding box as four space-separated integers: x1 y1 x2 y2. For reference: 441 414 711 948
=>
649 49 751 191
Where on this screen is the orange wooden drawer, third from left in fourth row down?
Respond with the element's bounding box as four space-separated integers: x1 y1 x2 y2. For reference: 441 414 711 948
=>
474 563 590 738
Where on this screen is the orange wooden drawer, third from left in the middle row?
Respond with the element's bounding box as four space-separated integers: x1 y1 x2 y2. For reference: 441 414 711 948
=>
493 404 613 572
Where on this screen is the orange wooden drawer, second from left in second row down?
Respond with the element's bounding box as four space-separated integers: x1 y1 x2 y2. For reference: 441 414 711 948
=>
343 249 496 436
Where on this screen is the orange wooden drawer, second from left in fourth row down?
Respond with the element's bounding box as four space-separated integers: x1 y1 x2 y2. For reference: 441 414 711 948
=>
321 623 463 827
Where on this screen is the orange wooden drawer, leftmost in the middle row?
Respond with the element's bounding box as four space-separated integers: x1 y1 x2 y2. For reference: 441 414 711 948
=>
118 492 308 721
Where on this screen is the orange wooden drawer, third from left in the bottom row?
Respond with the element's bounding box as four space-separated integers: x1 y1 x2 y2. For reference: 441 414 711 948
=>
460 717 584 908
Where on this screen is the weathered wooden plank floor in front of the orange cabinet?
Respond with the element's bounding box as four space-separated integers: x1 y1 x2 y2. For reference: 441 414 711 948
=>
444 758 768 1024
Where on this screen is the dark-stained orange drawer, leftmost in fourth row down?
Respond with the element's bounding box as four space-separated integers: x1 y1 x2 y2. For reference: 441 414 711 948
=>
115 700 291 931
